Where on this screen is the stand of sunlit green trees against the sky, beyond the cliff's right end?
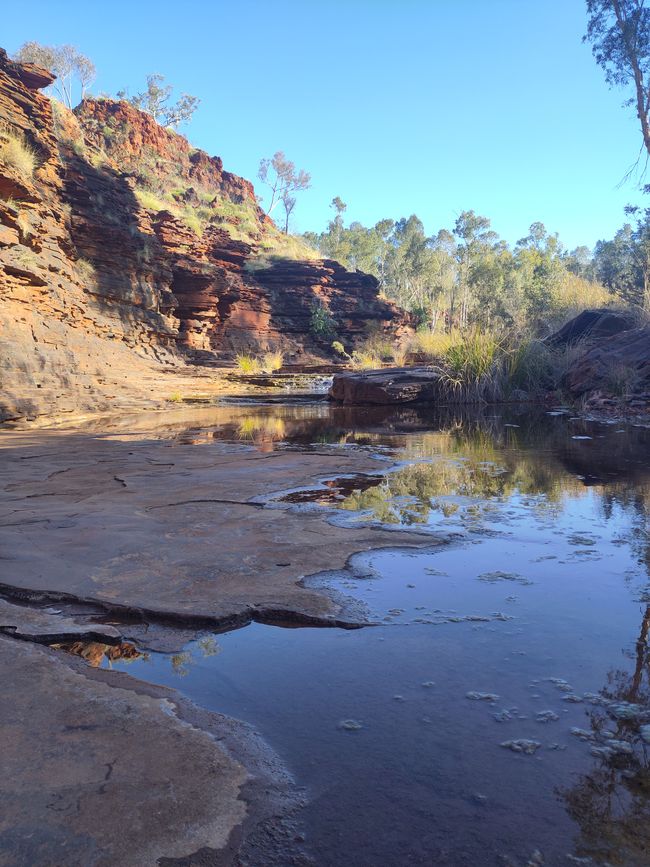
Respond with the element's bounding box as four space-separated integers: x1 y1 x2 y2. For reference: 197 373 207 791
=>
304 207 612 334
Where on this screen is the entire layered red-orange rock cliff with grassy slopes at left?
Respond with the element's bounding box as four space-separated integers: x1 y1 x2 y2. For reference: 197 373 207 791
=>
0 49 408 420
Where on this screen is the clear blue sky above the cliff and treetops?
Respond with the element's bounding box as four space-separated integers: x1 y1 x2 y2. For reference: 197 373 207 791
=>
0 0 641 247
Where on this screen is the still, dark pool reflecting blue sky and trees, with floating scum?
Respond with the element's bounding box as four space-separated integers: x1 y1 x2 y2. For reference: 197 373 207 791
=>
102 405 650 867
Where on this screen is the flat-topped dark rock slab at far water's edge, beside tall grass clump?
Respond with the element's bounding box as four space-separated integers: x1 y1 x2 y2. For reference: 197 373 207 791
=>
329 367 440 404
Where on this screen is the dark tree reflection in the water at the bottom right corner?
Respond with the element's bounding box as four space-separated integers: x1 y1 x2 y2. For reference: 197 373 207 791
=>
560 605 650 867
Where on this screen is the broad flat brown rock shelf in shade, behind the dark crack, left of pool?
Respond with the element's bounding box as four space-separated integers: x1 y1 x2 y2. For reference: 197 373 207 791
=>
0 413 436 626
